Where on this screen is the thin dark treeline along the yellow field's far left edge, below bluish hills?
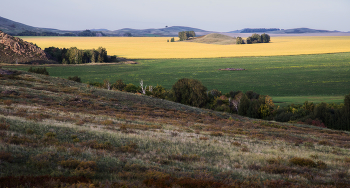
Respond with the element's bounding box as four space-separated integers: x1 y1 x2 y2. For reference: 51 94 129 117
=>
10 30 106 37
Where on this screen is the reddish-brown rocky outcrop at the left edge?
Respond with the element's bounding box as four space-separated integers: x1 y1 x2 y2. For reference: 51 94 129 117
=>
0 31 49 63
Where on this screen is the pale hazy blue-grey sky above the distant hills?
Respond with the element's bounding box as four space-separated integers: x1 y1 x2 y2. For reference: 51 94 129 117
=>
0 0 350 32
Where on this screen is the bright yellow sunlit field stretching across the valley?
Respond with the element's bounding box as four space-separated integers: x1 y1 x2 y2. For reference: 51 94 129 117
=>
21 36 350 59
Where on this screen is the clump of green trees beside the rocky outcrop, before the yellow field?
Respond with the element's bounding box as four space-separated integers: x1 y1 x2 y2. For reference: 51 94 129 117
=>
44 47 118 64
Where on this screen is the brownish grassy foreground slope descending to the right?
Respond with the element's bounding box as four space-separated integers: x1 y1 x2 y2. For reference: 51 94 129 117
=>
0 70 350 187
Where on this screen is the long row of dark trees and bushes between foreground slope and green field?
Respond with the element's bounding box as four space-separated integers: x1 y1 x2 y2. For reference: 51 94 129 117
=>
80 78 350 131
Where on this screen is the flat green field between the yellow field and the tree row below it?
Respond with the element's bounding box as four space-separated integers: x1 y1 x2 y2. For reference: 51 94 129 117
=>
6 53 350 103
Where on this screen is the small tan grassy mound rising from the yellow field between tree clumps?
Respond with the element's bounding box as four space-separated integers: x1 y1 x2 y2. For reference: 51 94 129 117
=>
187 33 236 45
